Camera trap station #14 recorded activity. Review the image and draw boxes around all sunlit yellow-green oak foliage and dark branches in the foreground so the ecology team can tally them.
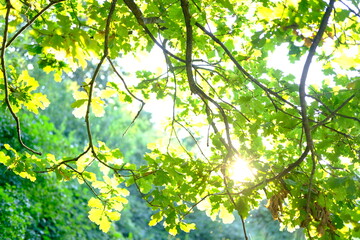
[0,0,360,239]
